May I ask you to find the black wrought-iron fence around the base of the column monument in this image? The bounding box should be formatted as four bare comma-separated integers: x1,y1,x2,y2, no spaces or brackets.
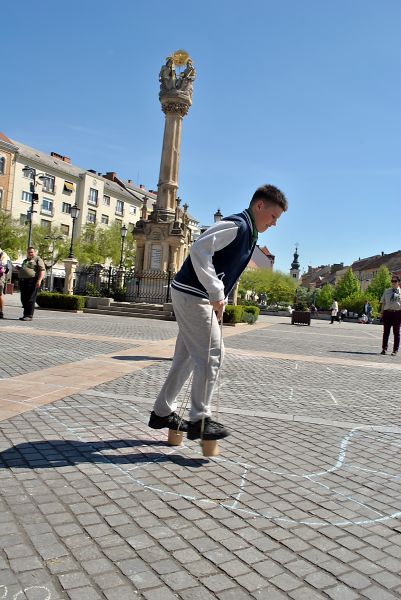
74,265,174,304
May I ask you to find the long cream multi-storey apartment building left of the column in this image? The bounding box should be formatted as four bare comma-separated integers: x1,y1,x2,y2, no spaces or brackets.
8,141,145,237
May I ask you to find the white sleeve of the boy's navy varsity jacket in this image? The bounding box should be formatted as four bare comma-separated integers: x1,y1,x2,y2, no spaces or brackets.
190,221,238,304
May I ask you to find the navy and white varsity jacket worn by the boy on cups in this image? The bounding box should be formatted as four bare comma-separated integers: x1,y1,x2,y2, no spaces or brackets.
171,210,257,302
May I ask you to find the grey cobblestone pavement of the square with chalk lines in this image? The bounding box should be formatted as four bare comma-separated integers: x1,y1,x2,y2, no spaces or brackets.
0,308,401,600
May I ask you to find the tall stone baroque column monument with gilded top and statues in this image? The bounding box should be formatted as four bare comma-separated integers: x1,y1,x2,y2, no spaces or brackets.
134,50,196,273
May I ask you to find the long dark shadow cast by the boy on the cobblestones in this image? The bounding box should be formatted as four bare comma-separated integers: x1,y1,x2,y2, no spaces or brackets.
0,440,209,469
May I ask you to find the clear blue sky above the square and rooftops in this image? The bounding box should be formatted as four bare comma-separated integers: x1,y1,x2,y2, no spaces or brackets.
0,0,401,271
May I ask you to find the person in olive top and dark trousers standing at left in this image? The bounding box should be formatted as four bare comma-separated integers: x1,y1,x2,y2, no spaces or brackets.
18,246,45,321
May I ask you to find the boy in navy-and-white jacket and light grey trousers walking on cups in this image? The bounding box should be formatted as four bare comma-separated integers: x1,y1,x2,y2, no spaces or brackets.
149,185,288,440
